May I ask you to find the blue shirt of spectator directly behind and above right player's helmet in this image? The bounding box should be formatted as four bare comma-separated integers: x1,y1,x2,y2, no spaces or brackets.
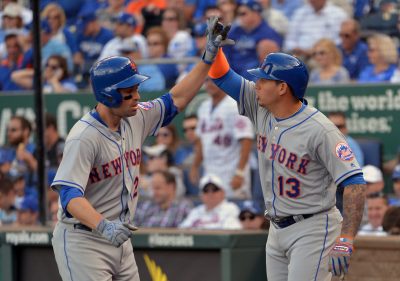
224,20,282,80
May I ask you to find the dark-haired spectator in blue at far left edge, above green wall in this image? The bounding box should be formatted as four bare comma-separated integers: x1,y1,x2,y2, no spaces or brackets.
0,33,26,91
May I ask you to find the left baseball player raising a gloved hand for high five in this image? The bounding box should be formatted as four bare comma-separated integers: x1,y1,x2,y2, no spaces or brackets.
52,18,232,281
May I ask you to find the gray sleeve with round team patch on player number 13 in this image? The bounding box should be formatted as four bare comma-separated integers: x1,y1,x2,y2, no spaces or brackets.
317,129,362,185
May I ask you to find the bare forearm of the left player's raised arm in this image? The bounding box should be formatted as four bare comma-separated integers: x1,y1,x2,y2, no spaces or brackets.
170,61,210,111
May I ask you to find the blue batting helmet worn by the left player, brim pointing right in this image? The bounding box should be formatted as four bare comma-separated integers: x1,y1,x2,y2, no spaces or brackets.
90,57,150,107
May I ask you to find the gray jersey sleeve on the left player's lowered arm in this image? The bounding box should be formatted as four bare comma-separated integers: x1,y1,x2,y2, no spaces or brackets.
51,139,96,193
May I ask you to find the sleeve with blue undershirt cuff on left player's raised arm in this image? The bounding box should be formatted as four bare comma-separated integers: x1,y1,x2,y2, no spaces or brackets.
138,93,178,138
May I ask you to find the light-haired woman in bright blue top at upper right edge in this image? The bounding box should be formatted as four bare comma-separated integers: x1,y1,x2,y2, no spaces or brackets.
358,34,398,83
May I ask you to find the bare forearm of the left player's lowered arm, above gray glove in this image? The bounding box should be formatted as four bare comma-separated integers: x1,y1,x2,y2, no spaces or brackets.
67,197,103,229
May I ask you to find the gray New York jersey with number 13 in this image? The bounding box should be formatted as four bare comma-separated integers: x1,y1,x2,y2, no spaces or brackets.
239,79,361,217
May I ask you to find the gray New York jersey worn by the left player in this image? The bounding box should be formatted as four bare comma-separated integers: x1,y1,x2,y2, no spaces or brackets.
52,99,165,224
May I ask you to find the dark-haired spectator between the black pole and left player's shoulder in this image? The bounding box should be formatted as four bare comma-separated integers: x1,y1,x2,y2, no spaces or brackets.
44,112,65,169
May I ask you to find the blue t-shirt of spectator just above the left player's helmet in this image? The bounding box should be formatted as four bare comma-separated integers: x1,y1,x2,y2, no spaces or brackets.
76,27,114,62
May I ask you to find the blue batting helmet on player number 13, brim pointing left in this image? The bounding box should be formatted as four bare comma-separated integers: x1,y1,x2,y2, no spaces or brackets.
247,53,308,99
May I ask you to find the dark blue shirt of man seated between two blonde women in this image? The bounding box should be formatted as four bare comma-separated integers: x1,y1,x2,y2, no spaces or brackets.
338,41,369,80
